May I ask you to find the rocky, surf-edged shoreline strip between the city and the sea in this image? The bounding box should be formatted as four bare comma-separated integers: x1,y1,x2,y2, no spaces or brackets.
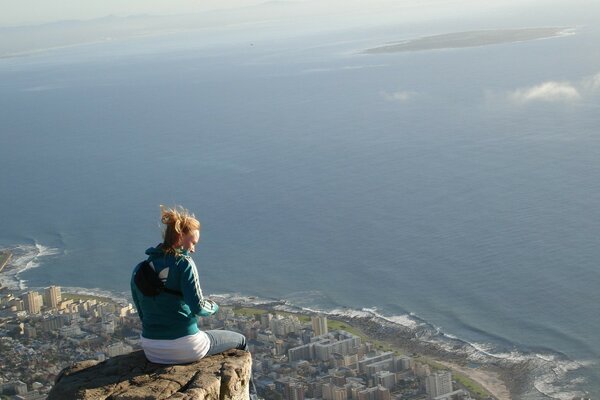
0,244,585,400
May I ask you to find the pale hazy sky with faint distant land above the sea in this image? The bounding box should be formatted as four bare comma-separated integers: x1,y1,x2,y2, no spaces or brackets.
0,0,600,57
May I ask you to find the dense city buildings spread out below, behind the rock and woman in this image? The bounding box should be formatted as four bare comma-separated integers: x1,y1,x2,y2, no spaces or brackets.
0,286,478,400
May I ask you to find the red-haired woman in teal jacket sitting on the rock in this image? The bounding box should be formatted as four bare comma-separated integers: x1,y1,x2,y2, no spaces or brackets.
131,206,253,366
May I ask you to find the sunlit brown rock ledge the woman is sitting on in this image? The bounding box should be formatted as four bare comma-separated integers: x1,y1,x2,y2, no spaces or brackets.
48,350,252,400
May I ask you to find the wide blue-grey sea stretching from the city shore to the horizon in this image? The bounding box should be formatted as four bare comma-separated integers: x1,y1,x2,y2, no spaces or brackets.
0,7,600,399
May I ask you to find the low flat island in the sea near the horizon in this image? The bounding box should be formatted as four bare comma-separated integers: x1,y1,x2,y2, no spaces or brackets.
362,27,572,54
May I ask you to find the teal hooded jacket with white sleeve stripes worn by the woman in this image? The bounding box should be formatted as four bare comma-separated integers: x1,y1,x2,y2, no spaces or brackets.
131,245,219,340
